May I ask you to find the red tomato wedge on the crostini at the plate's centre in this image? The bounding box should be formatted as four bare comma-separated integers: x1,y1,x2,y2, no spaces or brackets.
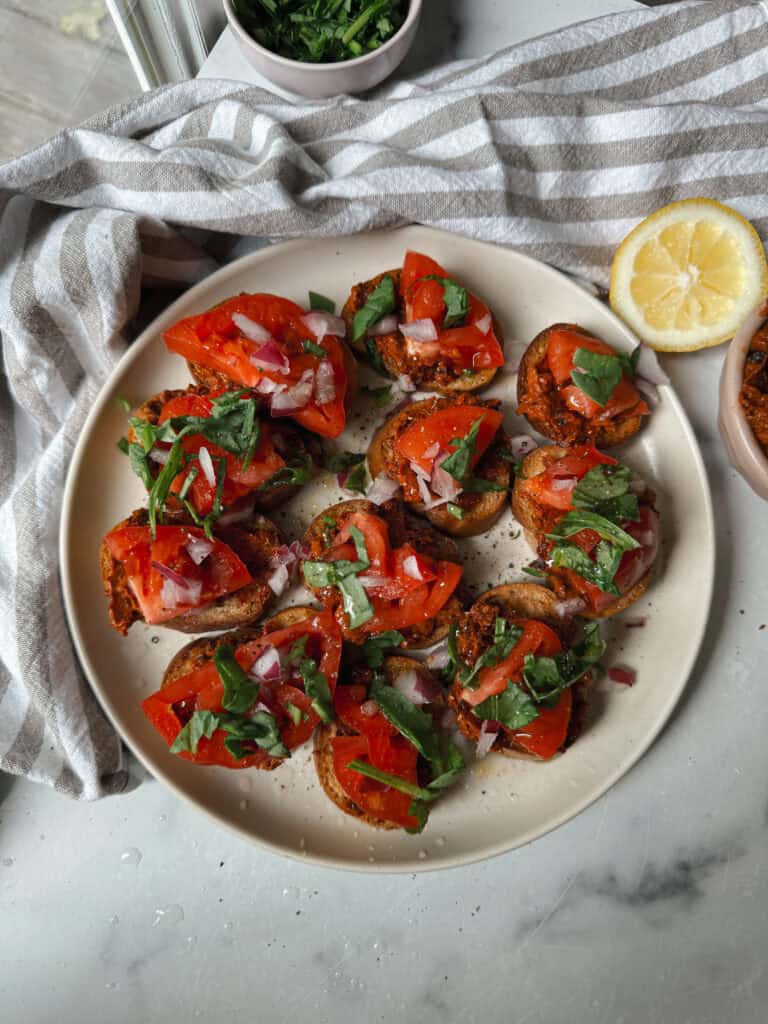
329,512,462,634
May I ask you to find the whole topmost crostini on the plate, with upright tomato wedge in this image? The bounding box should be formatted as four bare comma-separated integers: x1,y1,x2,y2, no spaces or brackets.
342,251,504,393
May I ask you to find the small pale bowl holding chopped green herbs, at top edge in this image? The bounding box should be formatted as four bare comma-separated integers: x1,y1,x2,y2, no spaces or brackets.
224,0,422,99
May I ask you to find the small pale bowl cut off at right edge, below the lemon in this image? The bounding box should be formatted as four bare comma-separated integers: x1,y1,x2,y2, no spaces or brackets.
718,300,768,500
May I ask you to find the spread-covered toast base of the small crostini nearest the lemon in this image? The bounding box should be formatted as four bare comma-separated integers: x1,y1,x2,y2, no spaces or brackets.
517,324,643,447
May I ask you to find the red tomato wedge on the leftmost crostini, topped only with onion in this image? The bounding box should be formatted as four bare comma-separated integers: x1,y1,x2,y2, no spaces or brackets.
104,526,253,626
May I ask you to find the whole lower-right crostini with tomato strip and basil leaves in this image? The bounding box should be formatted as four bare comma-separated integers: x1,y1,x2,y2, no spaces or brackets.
449,584,604,760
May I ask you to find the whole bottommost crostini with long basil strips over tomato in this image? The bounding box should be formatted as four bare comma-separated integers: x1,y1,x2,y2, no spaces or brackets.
314,656,464,831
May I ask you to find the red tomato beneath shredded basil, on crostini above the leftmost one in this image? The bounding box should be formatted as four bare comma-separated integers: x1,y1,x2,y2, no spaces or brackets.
156,394,286,515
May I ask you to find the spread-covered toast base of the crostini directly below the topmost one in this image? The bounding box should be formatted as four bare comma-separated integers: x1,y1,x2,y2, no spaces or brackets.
368,394,511,537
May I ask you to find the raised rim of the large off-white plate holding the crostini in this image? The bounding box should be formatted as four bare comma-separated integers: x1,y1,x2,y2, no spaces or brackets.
57,224,717,874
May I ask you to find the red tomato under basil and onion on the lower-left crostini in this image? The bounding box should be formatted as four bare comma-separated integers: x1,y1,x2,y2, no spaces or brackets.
141,611,341,768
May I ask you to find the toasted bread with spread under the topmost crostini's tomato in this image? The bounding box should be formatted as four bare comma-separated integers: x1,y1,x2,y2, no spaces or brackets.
341,269,502,394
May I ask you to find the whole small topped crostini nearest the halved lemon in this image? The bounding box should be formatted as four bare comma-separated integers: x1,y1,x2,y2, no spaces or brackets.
517,324,649,447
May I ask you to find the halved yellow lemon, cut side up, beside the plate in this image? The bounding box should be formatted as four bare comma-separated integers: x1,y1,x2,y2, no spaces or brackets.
610,199,768,352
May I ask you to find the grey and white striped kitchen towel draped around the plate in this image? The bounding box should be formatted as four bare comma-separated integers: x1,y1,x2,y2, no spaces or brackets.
0,0,768,799
